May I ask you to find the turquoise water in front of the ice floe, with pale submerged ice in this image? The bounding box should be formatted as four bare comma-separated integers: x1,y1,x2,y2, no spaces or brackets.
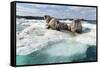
16,41,96,65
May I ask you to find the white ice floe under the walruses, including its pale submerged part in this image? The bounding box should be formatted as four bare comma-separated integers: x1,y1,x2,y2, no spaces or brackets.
16,20,96,57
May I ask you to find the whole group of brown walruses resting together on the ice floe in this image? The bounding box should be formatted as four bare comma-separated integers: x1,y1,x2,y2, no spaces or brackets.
44,15,82,33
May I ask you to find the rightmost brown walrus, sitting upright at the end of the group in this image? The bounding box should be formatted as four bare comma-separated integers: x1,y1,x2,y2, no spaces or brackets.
68,19,82,33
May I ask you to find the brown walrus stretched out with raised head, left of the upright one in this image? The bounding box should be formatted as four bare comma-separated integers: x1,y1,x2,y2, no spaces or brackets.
44,15,68,30
